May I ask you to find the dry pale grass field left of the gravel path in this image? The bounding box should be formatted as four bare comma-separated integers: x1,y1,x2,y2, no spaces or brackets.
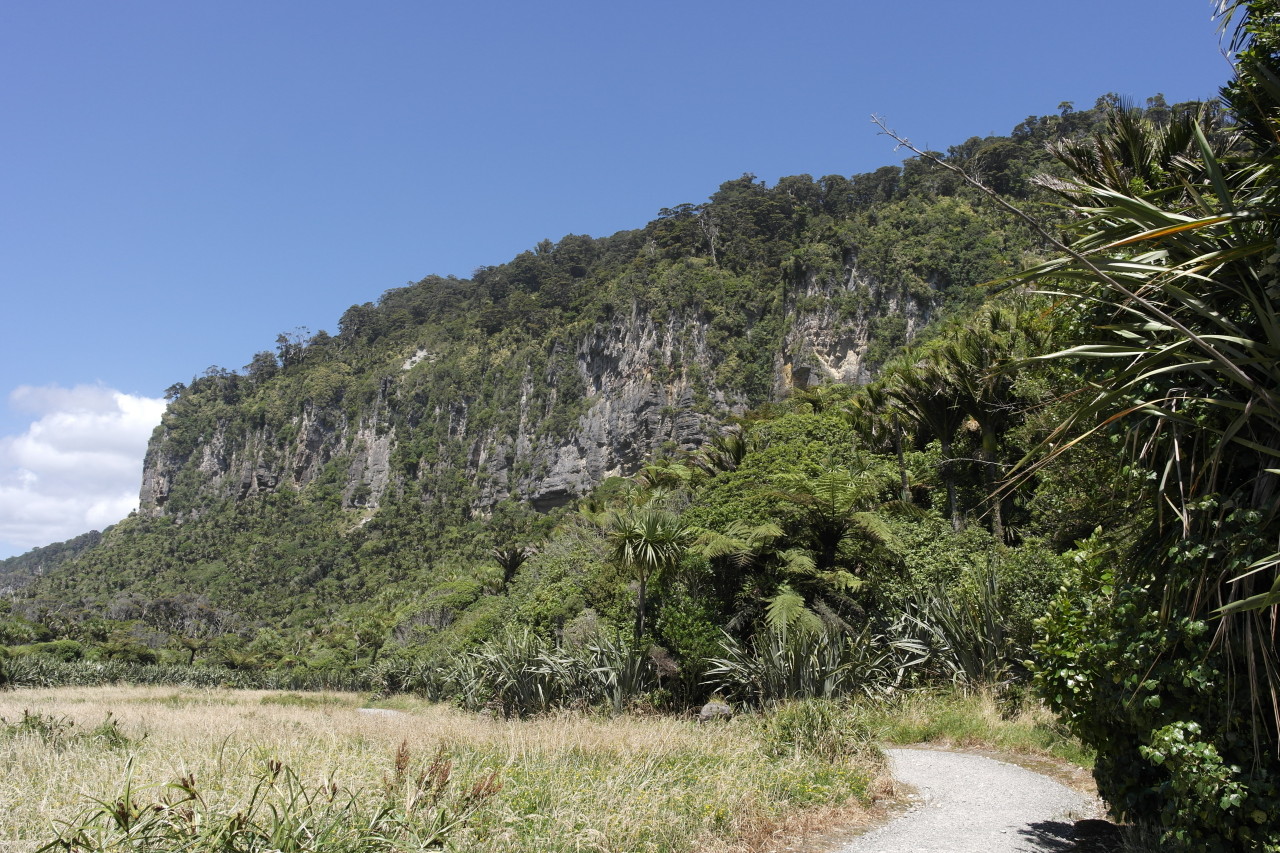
0,686,884,853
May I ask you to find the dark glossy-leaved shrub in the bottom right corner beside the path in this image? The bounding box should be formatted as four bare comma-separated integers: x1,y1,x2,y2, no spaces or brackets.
1036,540,1280,852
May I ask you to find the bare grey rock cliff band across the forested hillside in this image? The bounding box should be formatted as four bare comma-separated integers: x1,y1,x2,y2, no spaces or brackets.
140,269,929,516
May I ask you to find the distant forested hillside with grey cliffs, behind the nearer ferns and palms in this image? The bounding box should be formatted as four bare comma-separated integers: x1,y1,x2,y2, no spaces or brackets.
0,96,1152,637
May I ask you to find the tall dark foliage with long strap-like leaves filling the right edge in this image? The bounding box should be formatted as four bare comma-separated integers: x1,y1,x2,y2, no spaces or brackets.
1018,0,1280,850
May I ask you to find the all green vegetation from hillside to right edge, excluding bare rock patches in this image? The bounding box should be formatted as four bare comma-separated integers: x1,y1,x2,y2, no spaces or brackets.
0,0,1280,850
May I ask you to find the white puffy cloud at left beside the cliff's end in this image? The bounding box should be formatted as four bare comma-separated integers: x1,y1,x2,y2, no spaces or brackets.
0,386,165,556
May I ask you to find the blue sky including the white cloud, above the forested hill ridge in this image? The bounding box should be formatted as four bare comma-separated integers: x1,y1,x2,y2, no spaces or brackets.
0,0,1230,557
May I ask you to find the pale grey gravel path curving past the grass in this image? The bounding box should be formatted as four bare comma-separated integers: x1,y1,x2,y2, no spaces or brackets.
836,749,1097,853
